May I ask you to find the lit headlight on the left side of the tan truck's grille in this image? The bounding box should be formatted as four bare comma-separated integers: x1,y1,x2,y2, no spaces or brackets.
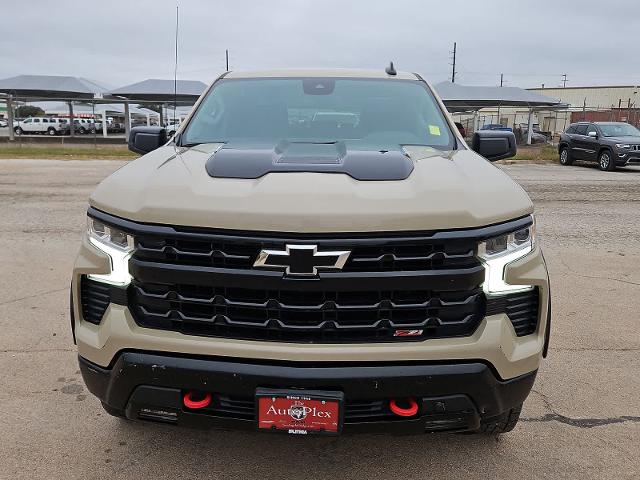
87,217,134,286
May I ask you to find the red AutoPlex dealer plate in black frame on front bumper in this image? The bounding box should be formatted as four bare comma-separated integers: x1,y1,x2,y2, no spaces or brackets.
256,388,344,435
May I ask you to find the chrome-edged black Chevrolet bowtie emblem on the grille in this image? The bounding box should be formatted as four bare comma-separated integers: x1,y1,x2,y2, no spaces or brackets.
253,245,351,276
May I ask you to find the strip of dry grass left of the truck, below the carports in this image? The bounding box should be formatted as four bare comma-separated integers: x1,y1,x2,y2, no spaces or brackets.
0,146,138,160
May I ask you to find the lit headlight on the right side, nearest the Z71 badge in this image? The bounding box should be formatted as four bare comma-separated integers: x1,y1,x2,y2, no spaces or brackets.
478,215,536,294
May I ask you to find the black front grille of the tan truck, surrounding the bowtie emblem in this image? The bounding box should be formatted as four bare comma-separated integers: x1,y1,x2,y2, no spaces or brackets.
89,209,531,343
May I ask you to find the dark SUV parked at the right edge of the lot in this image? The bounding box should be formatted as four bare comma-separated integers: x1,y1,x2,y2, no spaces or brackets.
558,122,640,170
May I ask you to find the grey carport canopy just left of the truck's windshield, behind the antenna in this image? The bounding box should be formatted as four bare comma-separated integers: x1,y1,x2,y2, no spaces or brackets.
108,78,207,105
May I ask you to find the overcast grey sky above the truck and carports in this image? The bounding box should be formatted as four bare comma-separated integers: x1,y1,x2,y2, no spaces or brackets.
0,0,640,87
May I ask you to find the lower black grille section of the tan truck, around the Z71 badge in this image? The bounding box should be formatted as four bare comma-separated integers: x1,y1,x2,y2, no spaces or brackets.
130,281,484,342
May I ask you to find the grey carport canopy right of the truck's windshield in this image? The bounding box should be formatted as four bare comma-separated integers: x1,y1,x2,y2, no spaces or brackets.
433,82,563,112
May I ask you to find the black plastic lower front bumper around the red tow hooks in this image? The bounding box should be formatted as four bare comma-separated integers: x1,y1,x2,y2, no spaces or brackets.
79,352,536,433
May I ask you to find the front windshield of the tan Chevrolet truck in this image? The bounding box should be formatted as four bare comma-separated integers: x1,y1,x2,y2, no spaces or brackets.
180,78,453,150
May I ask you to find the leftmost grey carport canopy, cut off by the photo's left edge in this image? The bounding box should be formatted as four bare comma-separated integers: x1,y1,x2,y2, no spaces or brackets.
0,75,107,99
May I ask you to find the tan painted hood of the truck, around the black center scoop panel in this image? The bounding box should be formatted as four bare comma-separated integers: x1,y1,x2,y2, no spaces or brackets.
90,144,533,233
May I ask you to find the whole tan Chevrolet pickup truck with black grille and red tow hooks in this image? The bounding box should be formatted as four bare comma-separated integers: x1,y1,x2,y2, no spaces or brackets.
71,69,550,434
